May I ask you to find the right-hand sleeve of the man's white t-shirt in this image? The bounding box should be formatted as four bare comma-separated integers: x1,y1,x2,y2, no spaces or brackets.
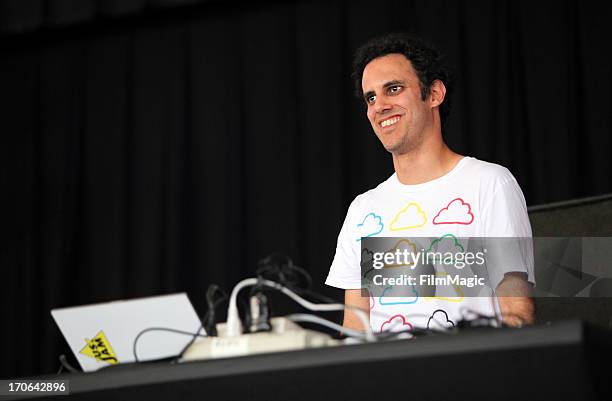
482,170,535,288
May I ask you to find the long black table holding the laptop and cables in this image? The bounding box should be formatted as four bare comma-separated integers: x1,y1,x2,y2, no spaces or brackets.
8,321,612,401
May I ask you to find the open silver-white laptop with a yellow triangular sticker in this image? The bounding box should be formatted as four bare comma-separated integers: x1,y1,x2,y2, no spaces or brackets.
51,293,203,372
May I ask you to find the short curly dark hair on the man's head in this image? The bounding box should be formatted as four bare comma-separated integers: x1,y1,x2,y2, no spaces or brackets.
352,33,453,126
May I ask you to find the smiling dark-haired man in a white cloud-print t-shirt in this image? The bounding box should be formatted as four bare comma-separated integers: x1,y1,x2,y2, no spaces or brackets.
326,34,534,332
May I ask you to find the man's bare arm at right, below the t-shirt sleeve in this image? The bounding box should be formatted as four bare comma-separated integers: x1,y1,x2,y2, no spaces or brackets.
496,272,535,326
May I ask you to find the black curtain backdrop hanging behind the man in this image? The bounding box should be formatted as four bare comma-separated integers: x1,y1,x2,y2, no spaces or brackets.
0,0,612,377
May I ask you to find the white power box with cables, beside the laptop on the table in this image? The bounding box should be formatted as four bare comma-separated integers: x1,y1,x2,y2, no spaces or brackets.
182,317,341,361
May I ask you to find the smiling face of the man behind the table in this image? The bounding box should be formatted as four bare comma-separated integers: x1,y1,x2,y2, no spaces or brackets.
361,54,432,154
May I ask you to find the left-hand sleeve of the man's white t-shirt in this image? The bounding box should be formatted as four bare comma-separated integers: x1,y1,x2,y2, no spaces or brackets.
325,198,361,290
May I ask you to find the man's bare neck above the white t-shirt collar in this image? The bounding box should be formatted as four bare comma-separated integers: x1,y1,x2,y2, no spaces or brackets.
393,138,463,185
